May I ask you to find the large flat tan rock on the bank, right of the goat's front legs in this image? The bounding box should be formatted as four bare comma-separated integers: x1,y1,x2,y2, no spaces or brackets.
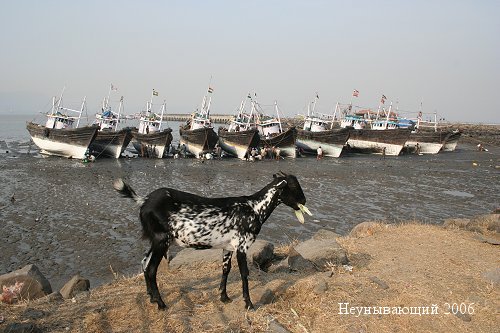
289,231,349,270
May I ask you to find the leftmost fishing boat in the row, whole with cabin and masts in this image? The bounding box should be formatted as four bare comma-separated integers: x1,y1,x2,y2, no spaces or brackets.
26,89,98,160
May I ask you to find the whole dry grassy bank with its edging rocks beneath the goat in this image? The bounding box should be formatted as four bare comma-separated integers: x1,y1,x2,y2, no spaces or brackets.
0,212,500,332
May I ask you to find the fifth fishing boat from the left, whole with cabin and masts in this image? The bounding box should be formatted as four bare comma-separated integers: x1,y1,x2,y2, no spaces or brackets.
218,99,260,160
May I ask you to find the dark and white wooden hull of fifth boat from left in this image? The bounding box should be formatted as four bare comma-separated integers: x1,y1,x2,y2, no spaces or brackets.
219,128,260,160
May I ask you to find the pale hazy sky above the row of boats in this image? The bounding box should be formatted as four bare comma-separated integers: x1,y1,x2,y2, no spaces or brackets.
0,0,500,123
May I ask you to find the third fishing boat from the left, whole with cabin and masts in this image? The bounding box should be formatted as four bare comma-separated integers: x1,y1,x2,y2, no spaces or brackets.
132,90,172,158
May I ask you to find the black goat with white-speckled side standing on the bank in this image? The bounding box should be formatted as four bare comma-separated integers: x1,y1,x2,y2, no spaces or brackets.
113,172,311,309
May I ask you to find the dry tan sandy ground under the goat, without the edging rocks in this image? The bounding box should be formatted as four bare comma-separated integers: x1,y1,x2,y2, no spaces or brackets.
0,223,500,332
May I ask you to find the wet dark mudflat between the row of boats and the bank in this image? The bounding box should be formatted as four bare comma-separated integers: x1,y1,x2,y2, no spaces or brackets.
0,142,500,289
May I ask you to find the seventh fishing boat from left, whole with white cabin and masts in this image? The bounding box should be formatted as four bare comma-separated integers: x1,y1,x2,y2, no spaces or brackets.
296,94,349,157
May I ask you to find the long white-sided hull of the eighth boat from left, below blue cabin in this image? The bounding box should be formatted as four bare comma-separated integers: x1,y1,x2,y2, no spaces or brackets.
347,128,411,156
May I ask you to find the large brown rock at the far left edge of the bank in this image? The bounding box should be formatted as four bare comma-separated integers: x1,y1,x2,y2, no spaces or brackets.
0,265,52,300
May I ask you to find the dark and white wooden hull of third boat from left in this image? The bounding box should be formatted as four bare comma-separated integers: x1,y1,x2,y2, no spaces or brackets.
132,128,172,158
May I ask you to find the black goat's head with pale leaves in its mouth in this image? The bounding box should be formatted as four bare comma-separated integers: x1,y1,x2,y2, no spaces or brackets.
273,171,312,223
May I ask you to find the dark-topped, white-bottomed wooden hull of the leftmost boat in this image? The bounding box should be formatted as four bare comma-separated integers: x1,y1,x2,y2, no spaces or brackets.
26,122,98,160
